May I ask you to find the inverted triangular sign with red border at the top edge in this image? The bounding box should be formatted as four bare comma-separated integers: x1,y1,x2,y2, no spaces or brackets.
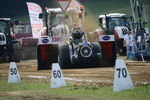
57,0,72,13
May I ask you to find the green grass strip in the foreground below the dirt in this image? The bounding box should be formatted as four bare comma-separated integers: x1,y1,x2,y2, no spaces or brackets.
0,81,150,100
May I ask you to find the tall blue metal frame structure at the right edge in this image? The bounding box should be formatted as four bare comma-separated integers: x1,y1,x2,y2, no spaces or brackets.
127,0,150,61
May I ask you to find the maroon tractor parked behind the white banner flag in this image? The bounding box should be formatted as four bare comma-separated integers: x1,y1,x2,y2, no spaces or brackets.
12,22,38,60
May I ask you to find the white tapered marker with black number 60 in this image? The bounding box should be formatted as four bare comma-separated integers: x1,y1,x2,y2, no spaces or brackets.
51,63,66,88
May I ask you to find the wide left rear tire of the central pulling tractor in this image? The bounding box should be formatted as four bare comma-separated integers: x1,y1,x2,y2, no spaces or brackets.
58,44,71,69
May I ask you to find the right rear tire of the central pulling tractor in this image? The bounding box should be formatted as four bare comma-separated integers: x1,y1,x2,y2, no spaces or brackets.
92,42,102,67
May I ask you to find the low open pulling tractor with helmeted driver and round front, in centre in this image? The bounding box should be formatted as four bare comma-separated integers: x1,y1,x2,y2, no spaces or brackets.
58,26,102,68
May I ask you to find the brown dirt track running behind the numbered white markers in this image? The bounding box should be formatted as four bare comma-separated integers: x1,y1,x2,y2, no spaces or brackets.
0,57,150,86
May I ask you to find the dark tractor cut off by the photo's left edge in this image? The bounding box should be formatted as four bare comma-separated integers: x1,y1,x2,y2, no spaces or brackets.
0,18,21,63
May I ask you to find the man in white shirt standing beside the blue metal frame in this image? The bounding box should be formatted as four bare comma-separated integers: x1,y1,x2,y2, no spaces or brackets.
123,30,134,57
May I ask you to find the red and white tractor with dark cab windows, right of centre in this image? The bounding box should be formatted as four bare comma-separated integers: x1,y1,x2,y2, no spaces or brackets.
99,13,128,55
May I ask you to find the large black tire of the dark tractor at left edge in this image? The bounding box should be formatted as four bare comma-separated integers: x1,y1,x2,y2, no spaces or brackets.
10,42,21,62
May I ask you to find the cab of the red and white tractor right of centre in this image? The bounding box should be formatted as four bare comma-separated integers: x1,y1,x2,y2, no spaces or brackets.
99,13,127,34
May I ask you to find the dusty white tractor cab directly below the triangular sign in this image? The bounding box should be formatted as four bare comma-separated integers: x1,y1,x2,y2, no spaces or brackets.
39,8,78,37
